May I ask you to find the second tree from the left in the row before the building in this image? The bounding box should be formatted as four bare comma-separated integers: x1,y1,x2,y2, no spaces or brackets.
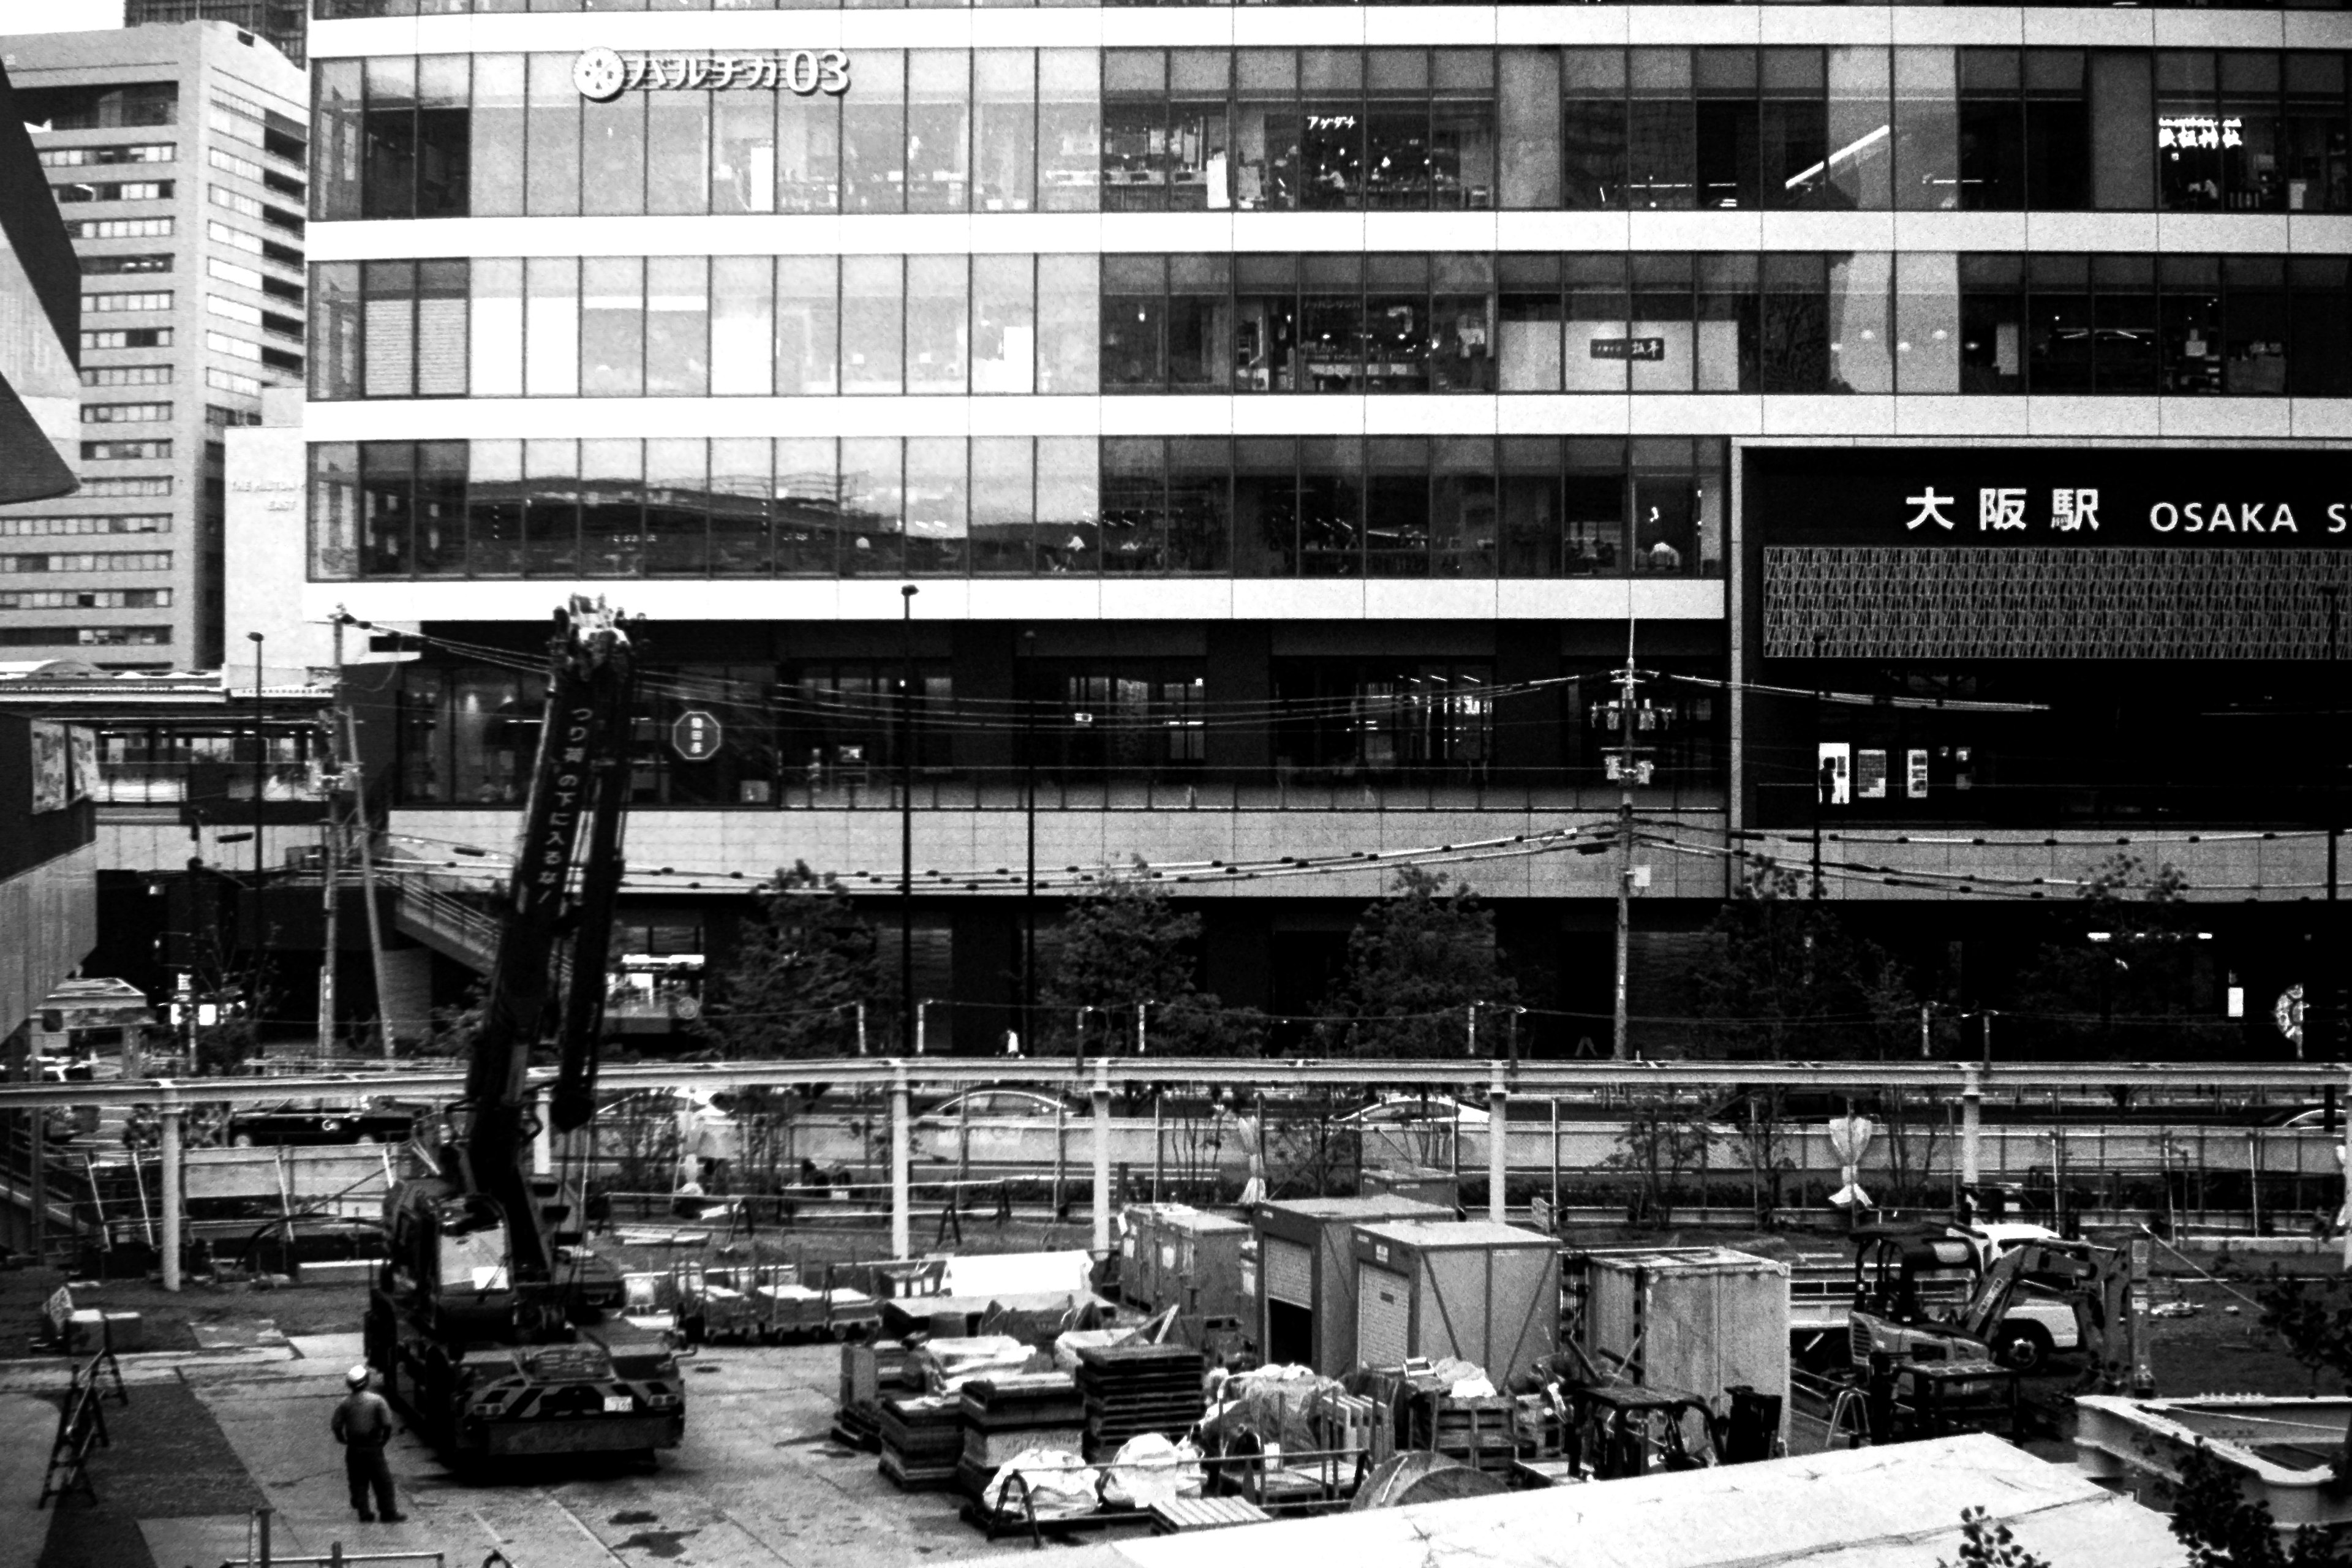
1039,861,1263,1055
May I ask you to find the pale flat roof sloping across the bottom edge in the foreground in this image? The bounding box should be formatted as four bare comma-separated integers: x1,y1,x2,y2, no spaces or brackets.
1061,1431,2187,1568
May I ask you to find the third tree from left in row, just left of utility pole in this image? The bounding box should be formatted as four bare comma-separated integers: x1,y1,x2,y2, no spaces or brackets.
1315,865,1520,1058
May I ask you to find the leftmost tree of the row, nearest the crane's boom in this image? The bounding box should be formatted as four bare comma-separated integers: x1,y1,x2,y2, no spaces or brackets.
696,861,882,1058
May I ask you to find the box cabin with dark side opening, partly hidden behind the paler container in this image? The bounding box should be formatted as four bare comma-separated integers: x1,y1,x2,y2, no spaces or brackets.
1251,1197,1453,1378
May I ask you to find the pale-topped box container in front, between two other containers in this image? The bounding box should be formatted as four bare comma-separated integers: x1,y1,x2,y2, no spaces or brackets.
1352,1220,1559,1387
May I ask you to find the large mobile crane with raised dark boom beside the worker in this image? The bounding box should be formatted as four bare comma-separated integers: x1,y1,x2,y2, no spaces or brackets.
364,595,687,1462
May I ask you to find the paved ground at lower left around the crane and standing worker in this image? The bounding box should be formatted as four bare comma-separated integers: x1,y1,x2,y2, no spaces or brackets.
0,1335,1009,1568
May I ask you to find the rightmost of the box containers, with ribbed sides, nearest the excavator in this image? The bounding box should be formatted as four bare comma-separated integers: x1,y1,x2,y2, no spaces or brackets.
1564,1246,1787,1434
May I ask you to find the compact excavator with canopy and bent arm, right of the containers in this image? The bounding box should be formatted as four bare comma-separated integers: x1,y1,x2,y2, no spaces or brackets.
1849,1234,2157,1438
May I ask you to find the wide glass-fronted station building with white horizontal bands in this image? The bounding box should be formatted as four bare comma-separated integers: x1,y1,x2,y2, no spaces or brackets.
301,0,2352,1049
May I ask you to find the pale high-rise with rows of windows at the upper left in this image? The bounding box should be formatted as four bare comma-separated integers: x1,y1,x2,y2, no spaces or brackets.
0,21,308,668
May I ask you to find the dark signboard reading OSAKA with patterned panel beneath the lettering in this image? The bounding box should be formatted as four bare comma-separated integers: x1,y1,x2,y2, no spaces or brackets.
1741,447,2352,661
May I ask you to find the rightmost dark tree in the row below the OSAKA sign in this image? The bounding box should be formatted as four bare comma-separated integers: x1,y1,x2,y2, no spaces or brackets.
2013,853,2237,1060
